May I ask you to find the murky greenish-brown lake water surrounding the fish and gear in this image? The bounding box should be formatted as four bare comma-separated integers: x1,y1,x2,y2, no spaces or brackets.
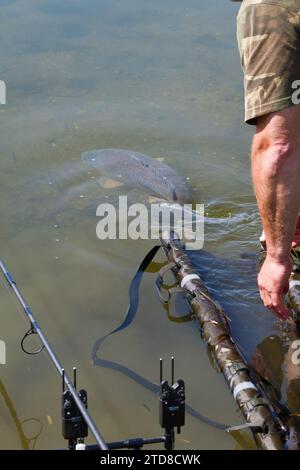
0,0,296,449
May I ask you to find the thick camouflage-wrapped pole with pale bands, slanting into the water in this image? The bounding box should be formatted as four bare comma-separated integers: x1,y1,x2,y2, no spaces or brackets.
161,232,284,450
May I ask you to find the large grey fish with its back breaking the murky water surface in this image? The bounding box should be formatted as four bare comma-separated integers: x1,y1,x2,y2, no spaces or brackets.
81,149,191,204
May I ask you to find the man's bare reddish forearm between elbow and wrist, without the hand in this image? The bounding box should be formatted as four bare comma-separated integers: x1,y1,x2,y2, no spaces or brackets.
252,136,300,261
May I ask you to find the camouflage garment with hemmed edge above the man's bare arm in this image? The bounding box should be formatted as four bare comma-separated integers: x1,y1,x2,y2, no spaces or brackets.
237,0,300,124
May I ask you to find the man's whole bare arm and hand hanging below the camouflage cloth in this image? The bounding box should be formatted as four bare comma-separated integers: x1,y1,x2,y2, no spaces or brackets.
252,106,300,319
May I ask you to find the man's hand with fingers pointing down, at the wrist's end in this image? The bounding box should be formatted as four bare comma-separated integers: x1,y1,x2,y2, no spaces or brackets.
257,254,292,320
